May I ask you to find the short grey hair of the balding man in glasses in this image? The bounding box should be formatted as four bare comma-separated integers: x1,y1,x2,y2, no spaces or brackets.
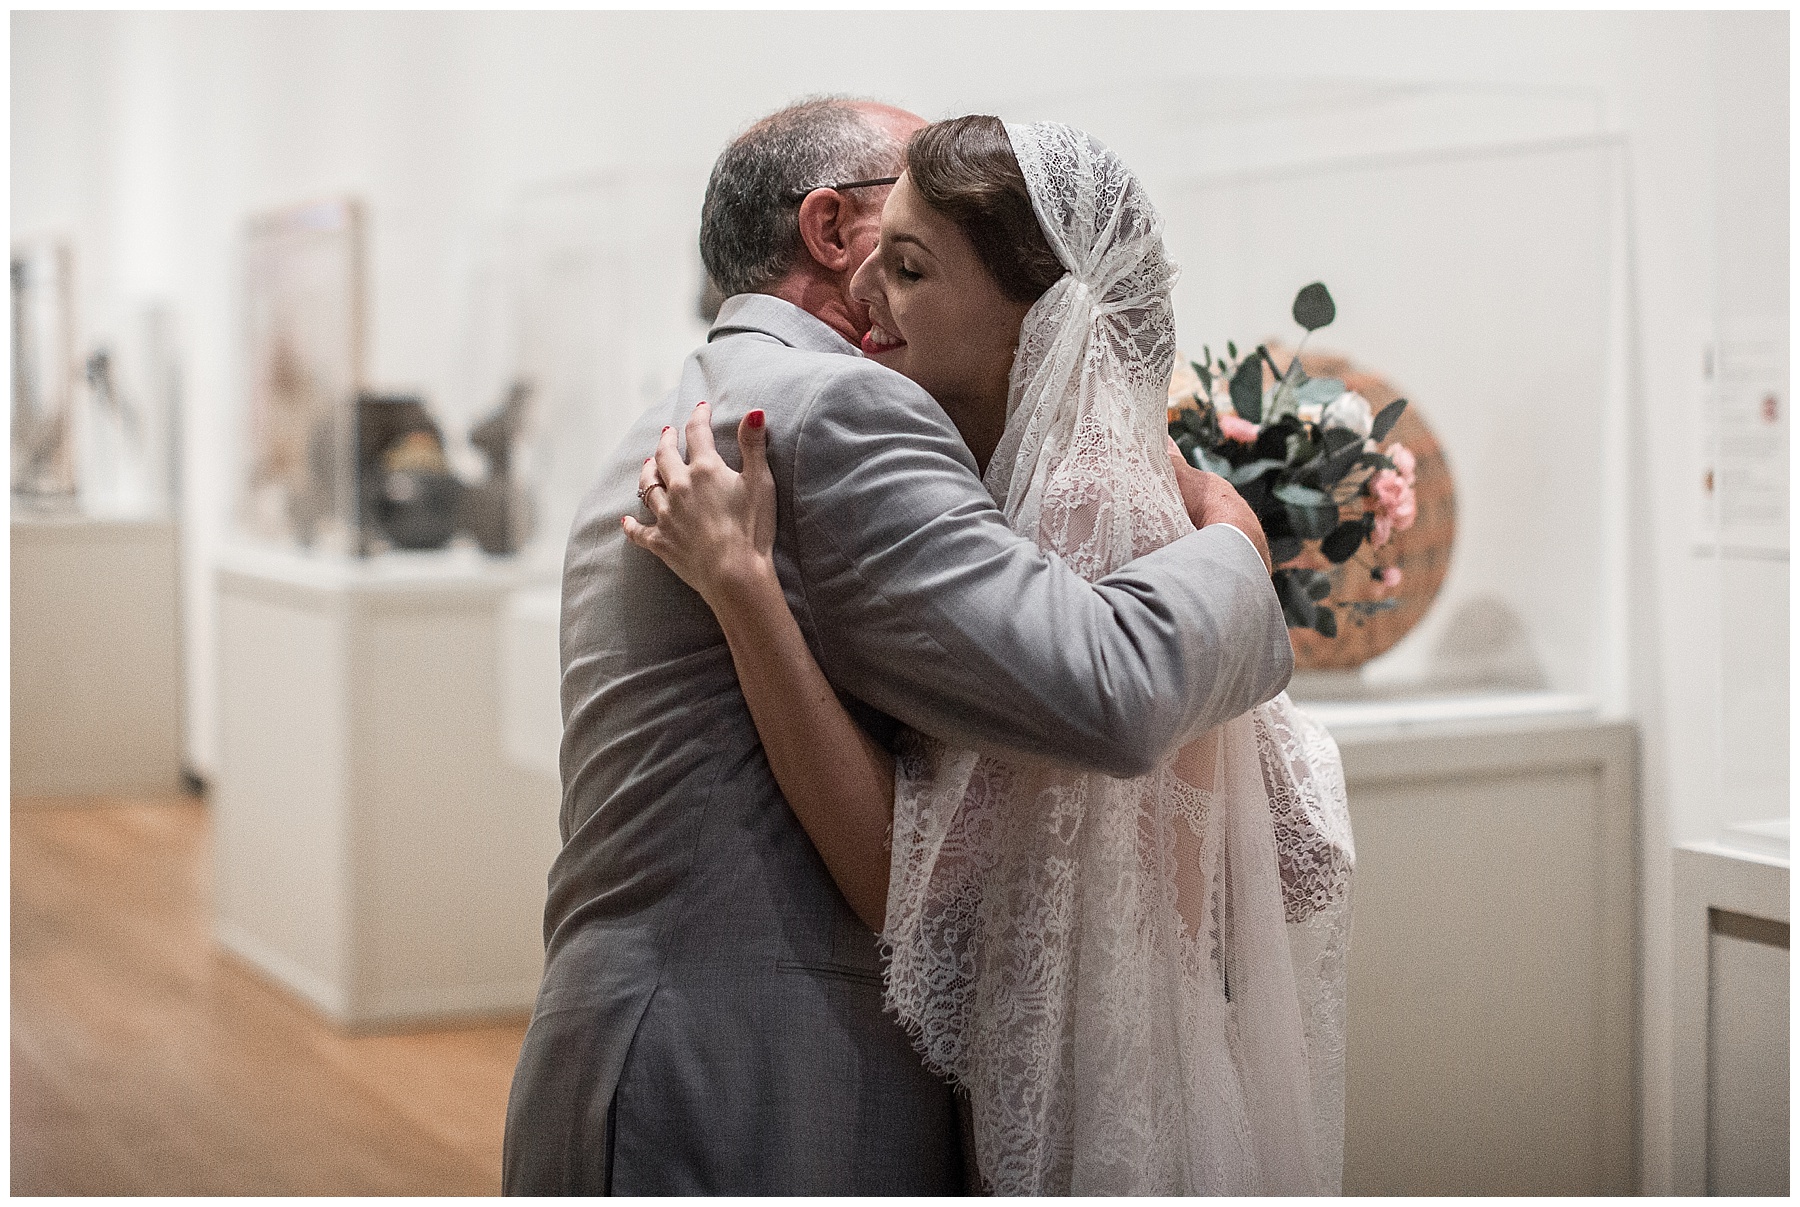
700,97,905,297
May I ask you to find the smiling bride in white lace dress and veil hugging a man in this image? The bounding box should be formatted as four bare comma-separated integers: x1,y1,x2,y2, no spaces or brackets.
623,117,1352,1194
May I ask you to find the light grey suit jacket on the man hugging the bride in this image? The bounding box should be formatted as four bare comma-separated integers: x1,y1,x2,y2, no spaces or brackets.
504,295,1291,1194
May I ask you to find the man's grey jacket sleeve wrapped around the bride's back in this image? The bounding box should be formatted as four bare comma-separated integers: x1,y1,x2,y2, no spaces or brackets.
779,358,1292,775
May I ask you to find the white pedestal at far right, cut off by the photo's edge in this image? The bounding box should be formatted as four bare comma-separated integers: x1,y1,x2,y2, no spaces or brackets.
1670,841,1789,1198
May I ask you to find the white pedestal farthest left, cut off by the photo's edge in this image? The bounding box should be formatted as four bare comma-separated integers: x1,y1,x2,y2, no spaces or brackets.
13,516,182,797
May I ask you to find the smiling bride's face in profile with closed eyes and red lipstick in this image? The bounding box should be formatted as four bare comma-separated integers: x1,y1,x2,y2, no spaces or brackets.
850,176,1031,453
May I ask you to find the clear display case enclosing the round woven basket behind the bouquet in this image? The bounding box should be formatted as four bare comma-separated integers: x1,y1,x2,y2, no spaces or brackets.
1012,81,1629,705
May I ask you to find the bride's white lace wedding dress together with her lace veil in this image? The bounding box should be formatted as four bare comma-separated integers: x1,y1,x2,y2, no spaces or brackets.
884,124,1352,1194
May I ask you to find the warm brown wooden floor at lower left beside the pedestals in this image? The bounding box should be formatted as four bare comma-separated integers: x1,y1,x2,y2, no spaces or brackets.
13,799,526,1194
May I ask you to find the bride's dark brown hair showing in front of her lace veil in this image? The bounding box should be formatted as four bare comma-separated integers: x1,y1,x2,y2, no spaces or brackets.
905,113,1064,302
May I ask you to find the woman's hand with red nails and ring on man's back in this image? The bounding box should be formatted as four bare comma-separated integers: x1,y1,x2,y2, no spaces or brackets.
619,403,776,610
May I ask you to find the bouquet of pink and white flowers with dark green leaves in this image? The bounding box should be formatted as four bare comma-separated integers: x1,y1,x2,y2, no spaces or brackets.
1168,282,1418,637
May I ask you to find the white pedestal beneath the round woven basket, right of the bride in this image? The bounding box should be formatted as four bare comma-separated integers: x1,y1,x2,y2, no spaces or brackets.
1301,693,1636,1194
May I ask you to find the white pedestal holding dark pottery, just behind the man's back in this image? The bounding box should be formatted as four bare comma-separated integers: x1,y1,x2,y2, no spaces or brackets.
214,550,560,1025
